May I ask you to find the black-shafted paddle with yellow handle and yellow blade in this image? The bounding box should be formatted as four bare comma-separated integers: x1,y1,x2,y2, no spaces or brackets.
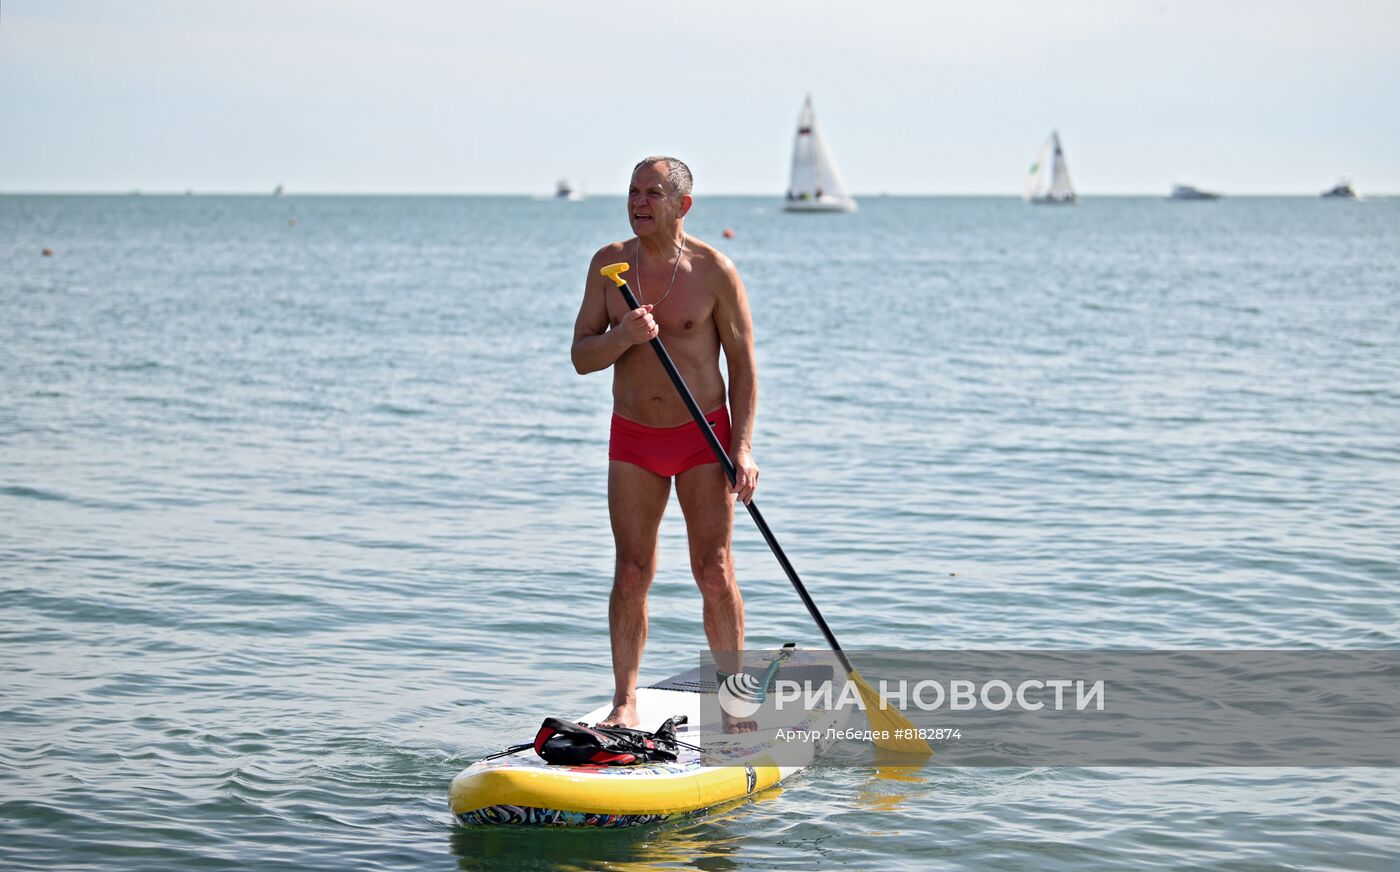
598,263,934,754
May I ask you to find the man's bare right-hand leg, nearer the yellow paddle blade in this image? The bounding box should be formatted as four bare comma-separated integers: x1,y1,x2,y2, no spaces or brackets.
676,463,756,731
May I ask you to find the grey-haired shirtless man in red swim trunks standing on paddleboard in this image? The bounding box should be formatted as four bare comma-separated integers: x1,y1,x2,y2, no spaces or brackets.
571,157,759,729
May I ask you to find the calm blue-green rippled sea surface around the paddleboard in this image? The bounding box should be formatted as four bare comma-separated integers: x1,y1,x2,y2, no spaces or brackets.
0,196,1400,871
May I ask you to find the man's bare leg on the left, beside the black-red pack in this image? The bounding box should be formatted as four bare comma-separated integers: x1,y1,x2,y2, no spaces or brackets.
601,460,671,726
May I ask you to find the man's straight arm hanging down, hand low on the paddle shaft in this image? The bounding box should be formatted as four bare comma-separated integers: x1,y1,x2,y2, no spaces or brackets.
714,255,759,502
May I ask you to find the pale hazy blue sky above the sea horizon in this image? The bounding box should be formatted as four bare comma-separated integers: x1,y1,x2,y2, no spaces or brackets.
0,0,1400,196
